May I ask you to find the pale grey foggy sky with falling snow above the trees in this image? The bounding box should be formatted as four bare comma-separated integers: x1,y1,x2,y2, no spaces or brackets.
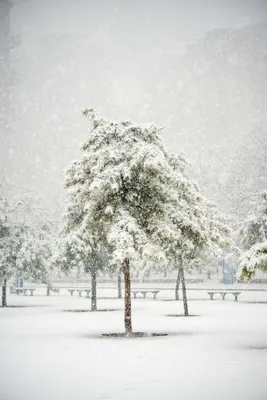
0,0,267,218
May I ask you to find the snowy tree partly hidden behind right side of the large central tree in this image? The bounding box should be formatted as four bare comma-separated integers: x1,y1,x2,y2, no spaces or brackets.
159,155,228,315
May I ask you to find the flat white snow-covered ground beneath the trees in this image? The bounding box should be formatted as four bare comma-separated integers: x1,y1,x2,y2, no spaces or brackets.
0,291,267,400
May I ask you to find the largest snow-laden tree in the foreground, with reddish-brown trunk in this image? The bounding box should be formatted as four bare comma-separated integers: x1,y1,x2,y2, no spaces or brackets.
66,110,186,333
